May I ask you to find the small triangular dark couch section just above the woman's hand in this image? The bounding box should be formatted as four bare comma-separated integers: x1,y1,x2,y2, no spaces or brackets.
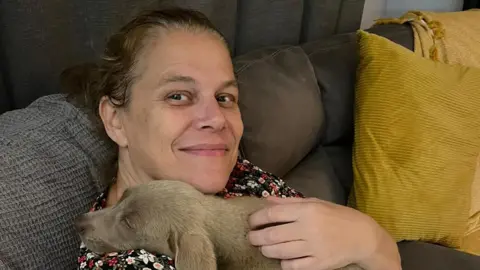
284,146,345,205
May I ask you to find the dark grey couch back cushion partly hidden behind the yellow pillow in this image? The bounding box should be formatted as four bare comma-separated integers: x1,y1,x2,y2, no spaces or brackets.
302,25,413,146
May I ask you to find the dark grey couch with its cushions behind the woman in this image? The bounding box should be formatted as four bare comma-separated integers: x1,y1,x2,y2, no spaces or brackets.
0,0,480,270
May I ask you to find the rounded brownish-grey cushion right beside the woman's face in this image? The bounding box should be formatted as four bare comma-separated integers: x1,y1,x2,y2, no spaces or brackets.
234,46,323,176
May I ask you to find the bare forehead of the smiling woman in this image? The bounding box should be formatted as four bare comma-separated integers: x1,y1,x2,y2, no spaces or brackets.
137,32,235,85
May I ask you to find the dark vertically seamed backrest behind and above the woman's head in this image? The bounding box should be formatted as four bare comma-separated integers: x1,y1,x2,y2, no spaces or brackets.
0,0,364,113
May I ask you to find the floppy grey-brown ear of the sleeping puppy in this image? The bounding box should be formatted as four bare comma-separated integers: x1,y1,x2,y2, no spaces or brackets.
175,233,217,270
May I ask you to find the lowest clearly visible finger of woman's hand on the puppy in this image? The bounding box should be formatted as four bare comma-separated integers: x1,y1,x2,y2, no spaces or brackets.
260,240,312,260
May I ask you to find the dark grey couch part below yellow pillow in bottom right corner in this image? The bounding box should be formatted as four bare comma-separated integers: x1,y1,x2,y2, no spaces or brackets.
398,241,480,270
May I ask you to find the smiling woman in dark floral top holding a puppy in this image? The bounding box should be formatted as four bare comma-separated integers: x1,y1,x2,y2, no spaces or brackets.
64,9,401,270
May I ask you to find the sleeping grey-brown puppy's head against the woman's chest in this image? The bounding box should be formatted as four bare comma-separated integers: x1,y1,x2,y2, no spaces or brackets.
75,180,205,256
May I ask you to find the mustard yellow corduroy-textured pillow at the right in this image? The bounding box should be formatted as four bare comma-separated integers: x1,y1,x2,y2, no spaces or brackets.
349,31,480,251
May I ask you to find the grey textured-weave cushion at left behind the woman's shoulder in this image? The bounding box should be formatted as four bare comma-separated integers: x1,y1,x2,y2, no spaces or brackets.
0,95,112,270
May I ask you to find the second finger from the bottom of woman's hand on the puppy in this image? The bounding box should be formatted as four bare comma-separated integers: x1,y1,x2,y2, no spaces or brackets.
248,223,303,246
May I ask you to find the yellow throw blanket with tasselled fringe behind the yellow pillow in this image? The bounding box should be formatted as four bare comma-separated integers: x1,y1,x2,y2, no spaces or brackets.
376,9,480,255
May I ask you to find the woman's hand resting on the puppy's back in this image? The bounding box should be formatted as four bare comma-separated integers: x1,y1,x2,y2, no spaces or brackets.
248,197,401,270
